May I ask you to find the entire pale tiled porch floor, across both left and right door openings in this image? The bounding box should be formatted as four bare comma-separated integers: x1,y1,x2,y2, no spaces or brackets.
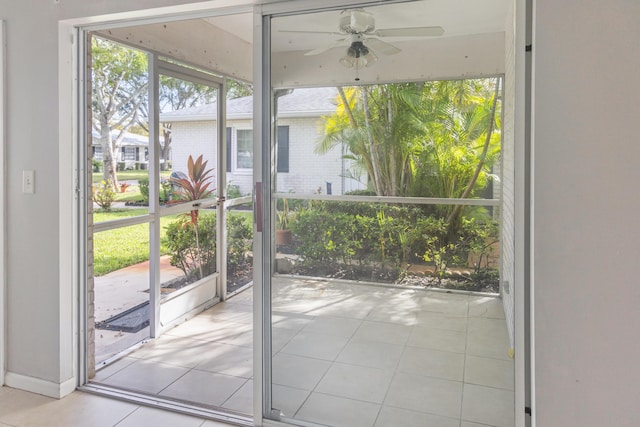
70,278,514,427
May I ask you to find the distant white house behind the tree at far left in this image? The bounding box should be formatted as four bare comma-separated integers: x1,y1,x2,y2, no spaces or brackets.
91,130,171,169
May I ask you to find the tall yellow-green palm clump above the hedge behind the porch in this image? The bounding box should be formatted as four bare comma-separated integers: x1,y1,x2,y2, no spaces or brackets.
316,78,500,237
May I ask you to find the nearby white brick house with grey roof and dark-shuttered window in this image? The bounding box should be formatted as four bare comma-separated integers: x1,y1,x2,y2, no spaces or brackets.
160,87,366,194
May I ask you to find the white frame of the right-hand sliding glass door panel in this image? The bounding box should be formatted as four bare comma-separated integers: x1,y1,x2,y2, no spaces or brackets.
253,0,535,427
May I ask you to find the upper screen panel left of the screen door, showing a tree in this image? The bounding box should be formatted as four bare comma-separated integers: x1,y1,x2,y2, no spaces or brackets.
88,37,149,222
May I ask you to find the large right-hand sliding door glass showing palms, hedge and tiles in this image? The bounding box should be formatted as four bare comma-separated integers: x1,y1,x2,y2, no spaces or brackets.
263,1,514,426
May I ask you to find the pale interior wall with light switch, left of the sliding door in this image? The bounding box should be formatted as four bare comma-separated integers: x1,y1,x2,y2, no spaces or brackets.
0,0,234,396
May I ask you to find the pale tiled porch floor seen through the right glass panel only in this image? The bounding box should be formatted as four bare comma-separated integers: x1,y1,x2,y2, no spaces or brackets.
273,279,514,427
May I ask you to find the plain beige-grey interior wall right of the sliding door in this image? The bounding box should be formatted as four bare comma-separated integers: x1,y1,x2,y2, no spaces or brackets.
533,0,640,427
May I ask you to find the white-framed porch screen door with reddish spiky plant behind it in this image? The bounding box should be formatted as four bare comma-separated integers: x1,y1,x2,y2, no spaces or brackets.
158,69,224,327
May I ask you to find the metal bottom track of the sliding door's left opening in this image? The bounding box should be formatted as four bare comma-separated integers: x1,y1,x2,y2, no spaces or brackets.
78,383,254,426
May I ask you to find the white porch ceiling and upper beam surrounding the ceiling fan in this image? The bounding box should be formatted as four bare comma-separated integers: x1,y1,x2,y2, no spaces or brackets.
96,0,509,87
